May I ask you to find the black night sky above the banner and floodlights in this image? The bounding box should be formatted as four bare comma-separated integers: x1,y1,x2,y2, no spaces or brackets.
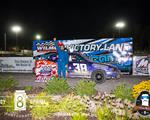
0,0,150,50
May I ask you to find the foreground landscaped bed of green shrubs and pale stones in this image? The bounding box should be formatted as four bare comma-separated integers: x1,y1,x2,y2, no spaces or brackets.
0,77,149,120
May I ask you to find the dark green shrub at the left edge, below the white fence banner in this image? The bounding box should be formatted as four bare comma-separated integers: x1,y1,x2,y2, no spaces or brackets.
0,76,18,91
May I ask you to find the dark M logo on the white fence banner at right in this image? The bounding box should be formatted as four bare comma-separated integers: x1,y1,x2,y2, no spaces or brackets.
136,57,149,74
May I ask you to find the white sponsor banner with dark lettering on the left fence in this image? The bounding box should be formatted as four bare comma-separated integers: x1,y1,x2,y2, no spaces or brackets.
0,57,34,73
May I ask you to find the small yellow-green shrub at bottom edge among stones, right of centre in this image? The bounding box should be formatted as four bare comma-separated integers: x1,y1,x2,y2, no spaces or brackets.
96,105,115,120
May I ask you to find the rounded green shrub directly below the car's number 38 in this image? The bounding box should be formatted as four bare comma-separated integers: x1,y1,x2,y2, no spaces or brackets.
74,80,96,96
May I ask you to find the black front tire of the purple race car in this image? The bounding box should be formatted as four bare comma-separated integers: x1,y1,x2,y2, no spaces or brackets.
91,70,106,83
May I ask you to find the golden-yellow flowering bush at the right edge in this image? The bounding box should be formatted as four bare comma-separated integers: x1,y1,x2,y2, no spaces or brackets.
132,80,150,98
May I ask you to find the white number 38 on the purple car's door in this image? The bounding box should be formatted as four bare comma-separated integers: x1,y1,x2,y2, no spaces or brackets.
73,63,88,72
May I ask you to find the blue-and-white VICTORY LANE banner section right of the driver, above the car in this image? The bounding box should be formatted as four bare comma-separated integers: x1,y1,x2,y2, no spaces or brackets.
63,38,133,74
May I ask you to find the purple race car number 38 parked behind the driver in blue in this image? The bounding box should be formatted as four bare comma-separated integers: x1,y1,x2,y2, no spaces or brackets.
34,53,120,83
